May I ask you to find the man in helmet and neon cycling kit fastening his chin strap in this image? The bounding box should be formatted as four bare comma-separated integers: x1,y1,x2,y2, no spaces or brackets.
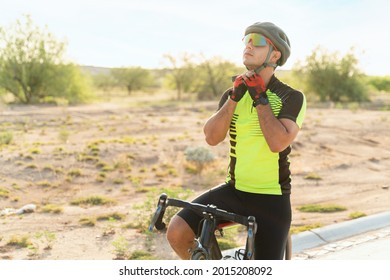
167,22,306,259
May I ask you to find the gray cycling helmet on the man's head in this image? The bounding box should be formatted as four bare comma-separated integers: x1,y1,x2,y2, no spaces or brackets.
245,22,291,66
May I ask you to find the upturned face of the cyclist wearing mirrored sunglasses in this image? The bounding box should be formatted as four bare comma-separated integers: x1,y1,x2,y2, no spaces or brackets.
242,33,280,70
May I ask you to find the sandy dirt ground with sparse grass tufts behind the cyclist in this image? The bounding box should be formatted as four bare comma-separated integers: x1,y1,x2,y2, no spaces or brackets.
0,96,390,260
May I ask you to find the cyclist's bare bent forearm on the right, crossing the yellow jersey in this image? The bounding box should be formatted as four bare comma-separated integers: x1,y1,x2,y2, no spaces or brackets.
256,105,299,153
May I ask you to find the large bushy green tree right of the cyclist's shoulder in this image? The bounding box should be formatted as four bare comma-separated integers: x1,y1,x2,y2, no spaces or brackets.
294,47,368,102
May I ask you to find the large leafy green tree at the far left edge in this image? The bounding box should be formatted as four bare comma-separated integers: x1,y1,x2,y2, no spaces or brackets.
0,16,88,104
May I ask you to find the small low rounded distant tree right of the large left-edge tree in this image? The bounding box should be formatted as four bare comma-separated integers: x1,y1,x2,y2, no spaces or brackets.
111,67,153,94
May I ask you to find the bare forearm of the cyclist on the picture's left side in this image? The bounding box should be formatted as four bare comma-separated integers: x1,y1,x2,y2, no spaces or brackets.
203,99,237,146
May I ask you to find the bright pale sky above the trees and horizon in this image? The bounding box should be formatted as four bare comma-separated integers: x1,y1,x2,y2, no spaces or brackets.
0,0,390,75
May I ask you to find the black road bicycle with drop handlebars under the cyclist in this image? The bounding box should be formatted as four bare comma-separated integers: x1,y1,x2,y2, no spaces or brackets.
149,193,291,260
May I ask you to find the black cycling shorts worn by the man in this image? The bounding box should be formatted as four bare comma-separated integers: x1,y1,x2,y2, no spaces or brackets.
177,183,291,260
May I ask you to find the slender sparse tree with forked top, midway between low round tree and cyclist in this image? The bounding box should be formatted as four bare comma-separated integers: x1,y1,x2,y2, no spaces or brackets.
164,53,195,100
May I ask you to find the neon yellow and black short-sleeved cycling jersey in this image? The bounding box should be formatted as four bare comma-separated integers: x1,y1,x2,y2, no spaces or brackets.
220,76,306,195
